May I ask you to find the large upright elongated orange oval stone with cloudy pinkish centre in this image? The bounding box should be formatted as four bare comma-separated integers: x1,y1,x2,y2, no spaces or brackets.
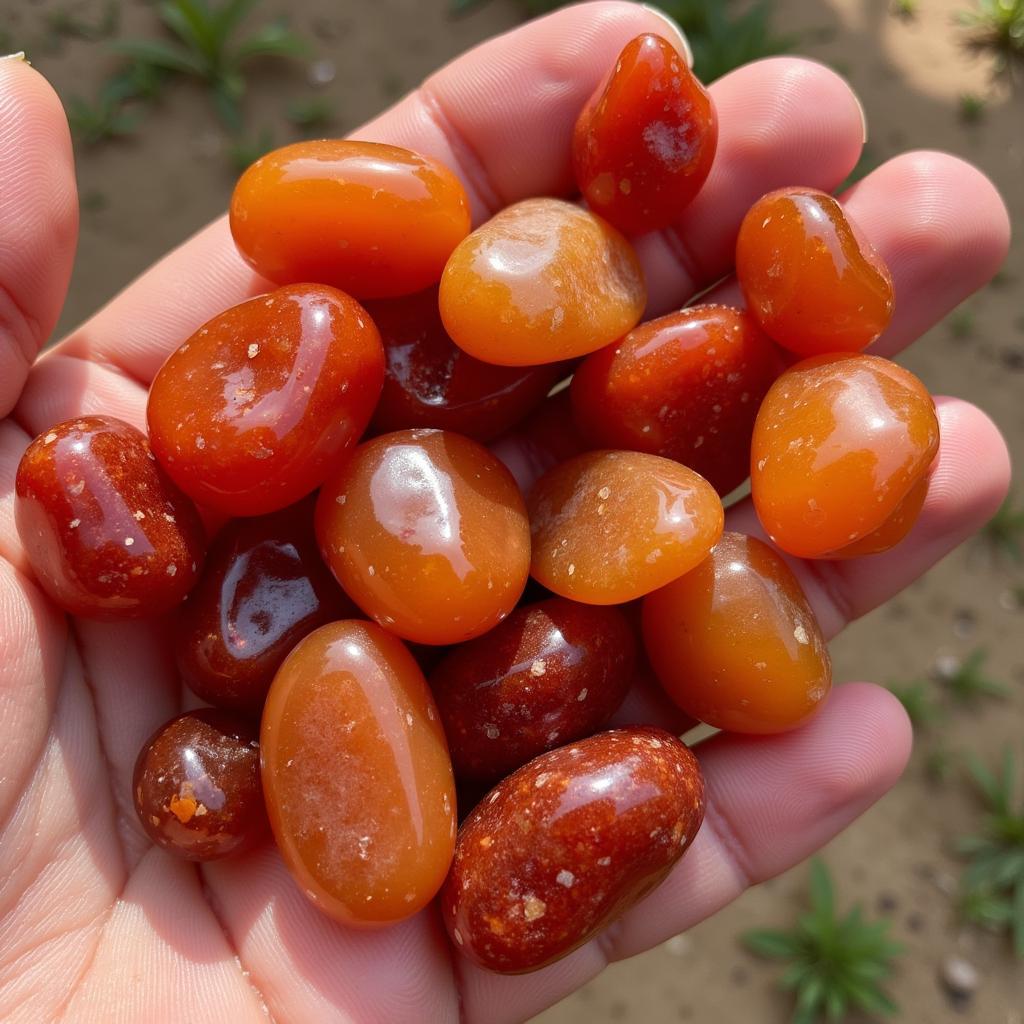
260,620,456,926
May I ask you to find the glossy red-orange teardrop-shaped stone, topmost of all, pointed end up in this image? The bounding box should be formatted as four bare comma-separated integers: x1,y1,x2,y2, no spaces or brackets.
572,34,718,234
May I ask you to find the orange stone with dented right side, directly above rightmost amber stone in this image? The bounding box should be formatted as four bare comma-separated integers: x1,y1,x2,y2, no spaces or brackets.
736,188,894,355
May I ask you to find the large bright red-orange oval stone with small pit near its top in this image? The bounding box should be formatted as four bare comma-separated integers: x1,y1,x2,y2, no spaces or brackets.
147,285,384,516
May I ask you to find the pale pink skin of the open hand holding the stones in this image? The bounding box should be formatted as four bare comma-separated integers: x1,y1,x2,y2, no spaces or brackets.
0,2,1009,1024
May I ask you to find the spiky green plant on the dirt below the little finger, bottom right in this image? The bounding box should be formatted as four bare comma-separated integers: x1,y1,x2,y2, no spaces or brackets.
742,858,903,1024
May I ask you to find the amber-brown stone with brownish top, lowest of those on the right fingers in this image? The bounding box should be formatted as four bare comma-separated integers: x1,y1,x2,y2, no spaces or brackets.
643,534,831,733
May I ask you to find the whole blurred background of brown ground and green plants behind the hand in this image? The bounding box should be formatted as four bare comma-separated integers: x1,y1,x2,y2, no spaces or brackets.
0,0,1024,1024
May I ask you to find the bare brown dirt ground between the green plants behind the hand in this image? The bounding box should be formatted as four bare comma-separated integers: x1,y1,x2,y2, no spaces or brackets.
0,0,1024,1024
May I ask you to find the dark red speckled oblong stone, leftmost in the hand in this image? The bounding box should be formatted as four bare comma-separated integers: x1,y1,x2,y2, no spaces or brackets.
14,416,206,618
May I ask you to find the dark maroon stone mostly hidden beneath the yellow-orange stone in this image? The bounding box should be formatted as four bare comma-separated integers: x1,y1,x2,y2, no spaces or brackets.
367,288,560,441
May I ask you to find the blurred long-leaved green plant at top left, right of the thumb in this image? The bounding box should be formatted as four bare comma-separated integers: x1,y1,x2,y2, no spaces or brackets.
112,0,306,133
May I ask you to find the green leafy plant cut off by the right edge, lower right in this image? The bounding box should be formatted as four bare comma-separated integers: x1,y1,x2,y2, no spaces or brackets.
956,746,1024,956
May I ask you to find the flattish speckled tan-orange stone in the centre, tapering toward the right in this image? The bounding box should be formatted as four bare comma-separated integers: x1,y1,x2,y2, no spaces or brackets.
529,452,724,604
